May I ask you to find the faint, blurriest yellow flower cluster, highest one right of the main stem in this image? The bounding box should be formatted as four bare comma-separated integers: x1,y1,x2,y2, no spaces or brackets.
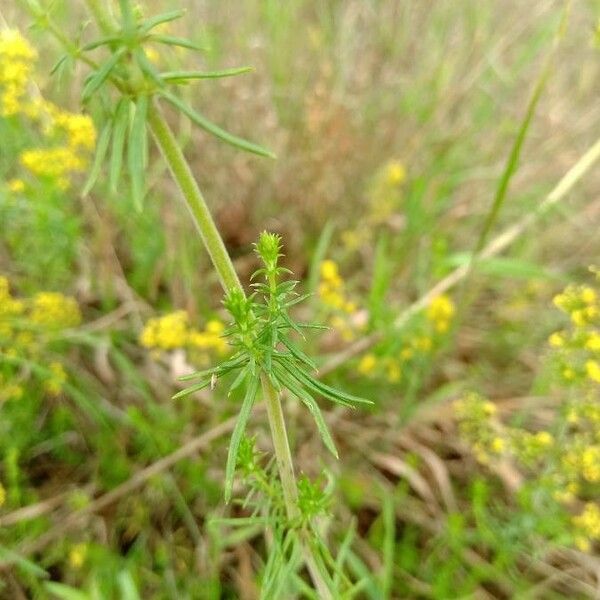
342,159,406,250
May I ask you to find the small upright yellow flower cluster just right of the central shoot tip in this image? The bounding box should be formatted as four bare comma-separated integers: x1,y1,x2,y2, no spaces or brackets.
318,259,360,342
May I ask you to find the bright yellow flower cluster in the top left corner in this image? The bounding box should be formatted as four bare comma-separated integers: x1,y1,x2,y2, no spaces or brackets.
0,30,96,186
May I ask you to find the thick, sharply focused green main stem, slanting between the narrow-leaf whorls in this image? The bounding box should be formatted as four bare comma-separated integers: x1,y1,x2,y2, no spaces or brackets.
148,103,333,600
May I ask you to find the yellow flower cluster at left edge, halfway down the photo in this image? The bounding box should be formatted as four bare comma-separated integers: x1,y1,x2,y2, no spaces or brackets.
0,276,81,402
